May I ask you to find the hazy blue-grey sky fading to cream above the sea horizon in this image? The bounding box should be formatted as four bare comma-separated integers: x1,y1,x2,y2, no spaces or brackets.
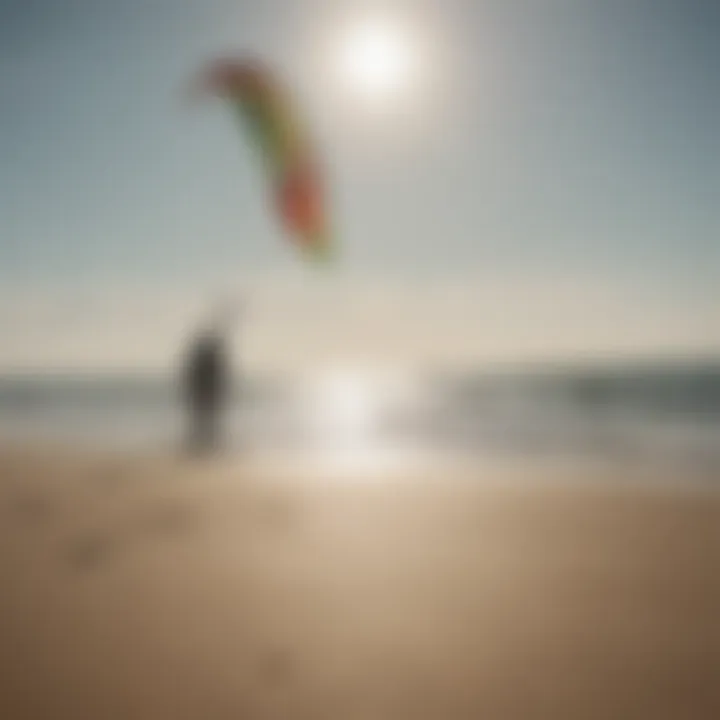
0,0,720,368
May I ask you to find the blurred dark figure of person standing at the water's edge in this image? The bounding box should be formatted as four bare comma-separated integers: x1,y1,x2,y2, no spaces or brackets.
184,333,228,450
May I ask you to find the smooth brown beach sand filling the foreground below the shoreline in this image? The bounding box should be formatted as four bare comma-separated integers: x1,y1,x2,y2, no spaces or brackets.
0,448,720,720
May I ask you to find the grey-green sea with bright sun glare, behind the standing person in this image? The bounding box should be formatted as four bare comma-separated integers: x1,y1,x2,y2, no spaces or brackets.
0,361,720,479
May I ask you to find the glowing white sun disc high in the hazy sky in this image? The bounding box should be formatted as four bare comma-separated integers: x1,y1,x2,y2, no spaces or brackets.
337,19,416,104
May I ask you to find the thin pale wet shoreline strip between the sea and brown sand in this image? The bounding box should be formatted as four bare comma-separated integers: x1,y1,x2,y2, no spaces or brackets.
0,439,720,495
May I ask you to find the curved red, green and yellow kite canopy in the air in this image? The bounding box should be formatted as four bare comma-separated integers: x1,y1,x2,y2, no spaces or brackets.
195,59,331,259
